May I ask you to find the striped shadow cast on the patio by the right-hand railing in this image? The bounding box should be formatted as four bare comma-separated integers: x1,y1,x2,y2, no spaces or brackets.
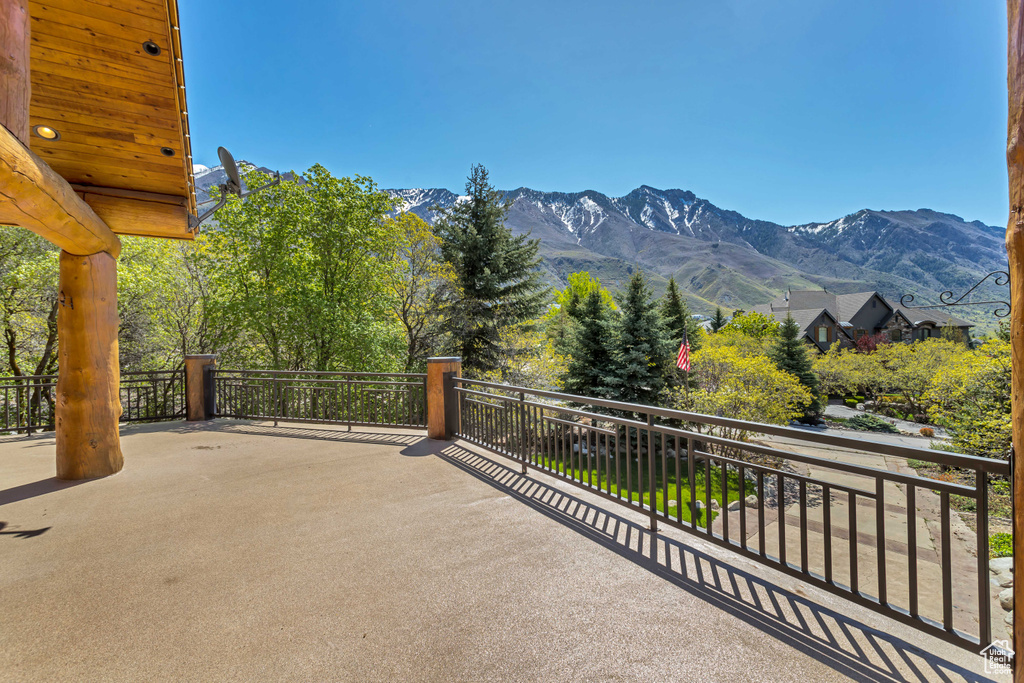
433,441,992,681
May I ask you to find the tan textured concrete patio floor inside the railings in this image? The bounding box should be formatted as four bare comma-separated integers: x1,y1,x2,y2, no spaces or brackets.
0,420,1007,682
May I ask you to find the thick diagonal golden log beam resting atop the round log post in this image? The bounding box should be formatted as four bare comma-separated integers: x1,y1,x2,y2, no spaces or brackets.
0,126,121,258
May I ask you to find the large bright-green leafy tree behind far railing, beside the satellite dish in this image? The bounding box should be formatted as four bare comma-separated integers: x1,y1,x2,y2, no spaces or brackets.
206,165,406,372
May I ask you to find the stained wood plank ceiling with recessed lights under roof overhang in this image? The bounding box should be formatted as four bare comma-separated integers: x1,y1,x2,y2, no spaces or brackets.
29,0,196,240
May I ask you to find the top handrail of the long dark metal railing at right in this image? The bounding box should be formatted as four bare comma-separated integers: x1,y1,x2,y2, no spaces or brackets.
452,377,1010,475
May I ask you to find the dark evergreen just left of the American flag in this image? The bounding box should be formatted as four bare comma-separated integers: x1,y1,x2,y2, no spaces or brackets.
610,272,672,403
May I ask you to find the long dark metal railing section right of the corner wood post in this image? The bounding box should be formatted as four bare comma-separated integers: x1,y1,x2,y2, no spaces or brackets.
452,378,1010,651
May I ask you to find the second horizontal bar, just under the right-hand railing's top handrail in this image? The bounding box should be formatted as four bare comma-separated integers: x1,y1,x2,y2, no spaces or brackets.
456,388,979,498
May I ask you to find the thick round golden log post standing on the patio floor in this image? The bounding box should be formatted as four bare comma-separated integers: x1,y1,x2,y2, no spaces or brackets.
56,252,124,479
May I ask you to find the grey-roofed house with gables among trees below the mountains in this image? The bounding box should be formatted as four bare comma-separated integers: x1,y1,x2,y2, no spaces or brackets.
752,290,974,352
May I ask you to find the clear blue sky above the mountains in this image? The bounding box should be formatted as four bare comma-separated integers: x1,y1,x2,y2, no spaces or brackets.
179,0,1008,225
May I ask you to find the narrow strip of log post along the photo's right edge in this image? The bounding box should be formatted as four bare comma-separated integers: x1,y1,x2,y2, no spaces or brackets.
1007,0,1024,671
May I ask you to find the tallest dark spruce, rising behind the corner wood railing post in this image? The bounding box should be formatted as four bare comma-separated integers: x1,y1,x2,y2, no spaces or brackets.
434,165,549,375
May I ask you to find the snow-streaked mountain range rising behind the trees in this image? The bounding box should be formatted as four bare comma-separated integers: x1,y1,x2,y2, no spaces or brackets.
188,167,1007,312
